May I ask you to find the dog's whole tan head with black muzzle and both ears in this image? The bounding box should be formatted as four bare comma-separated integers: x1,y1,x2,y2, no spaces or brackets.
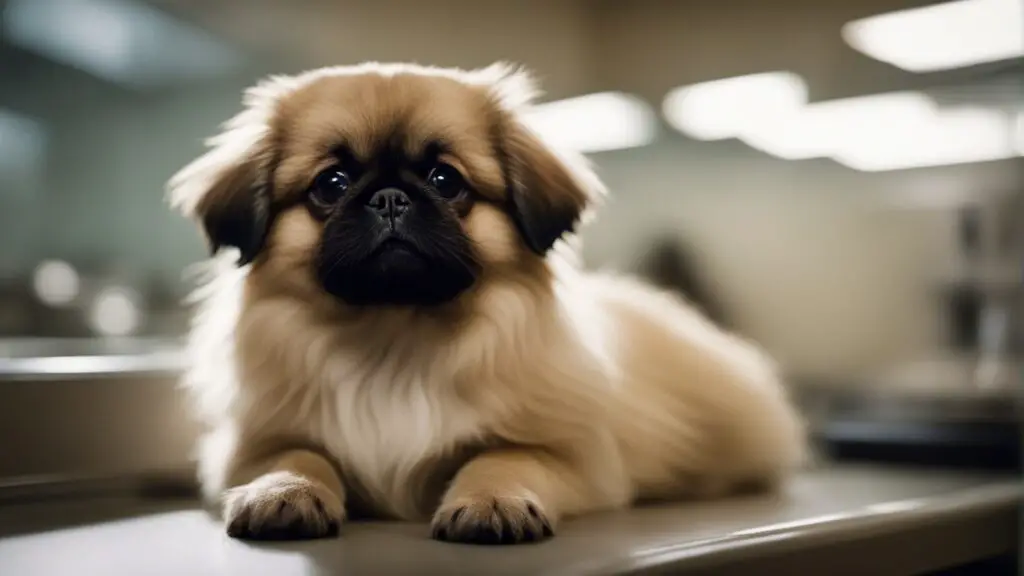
170,65,603,306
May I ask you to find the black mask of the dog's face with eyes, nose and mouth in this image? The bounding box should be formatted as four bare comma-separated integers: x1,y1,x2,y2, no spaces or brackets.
306,136,480,304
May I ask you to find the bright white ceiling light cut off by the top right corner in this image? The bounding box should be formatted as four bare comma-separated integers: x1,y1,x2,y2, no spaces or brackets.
842,0,1024,72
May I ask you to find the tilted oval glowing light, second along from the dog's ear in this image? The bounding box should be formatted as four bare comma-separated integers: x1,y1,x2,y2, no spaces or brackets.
662,72,807,140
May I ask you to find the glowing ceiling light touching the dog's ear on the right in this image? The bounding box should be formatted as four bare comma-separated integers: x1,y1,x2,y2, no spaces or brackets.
524,92,657,154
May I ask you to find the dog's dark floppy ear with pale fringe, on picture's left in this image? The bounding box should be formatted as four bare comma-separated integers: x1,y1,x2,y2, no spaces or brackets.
167,78,291,265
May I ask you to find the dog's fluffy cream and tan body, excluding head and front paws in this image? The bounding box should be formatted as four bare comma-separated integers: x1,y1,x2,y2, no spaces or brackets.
186,249,803,520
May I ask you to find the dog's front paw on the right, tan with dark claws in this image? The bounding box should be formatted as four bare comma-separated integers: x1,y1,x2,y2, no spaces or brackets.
431,496,554,544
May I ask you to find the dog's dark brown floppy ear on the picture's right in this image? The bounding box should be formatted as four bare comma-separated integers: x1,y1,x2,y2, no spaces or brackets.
484,65,605,255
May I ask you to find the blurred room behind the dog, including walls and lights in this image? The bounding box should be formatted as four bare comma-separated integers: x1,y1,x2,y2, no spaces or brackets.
0,0,1024,487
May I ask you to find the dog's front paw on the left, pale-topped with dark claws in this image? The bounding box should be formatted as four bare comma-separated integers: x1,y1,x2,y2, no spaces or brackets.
223,471,344,540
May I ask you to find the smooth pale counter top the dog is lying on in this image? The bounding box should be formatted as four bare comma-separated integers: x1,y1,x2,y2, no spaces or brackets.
0,465,1024,576
